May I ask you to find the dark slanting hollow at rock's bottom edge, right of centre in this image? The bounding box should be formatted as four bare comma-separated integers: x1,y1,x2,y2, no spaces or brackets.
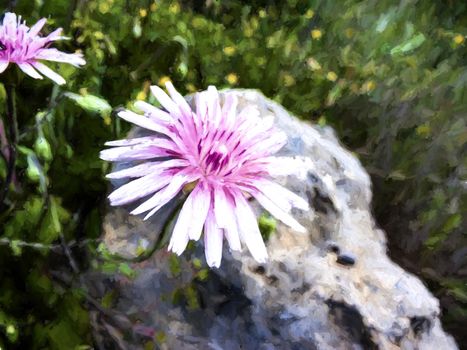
326,299,378,350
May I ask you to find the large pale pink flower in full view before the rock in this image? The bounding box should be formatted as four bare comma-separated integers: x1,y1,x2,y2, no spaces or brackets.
100,82,308,267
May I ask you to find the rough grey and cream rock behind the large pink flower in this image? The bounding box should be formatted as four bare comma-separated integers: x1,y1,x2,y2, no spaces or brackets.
97,90,457,350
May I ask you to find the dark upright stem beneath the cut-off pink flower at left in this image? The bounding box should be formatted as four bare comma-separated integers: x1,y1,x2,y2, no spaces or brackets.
0,83,18,209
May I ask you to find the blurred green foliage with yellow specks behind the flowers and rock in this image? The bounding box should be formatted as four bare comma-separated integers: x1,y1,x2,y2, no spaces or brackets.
0,0,467,349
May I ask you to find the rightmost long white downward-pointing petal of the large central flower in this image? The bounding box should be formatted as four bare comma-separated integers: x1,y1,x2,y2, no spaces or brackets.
234,191,268,263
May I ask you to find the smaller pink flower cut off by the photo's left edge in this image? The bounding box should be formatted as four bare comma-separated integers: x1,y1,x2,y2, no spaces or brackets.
0,12,86,85
